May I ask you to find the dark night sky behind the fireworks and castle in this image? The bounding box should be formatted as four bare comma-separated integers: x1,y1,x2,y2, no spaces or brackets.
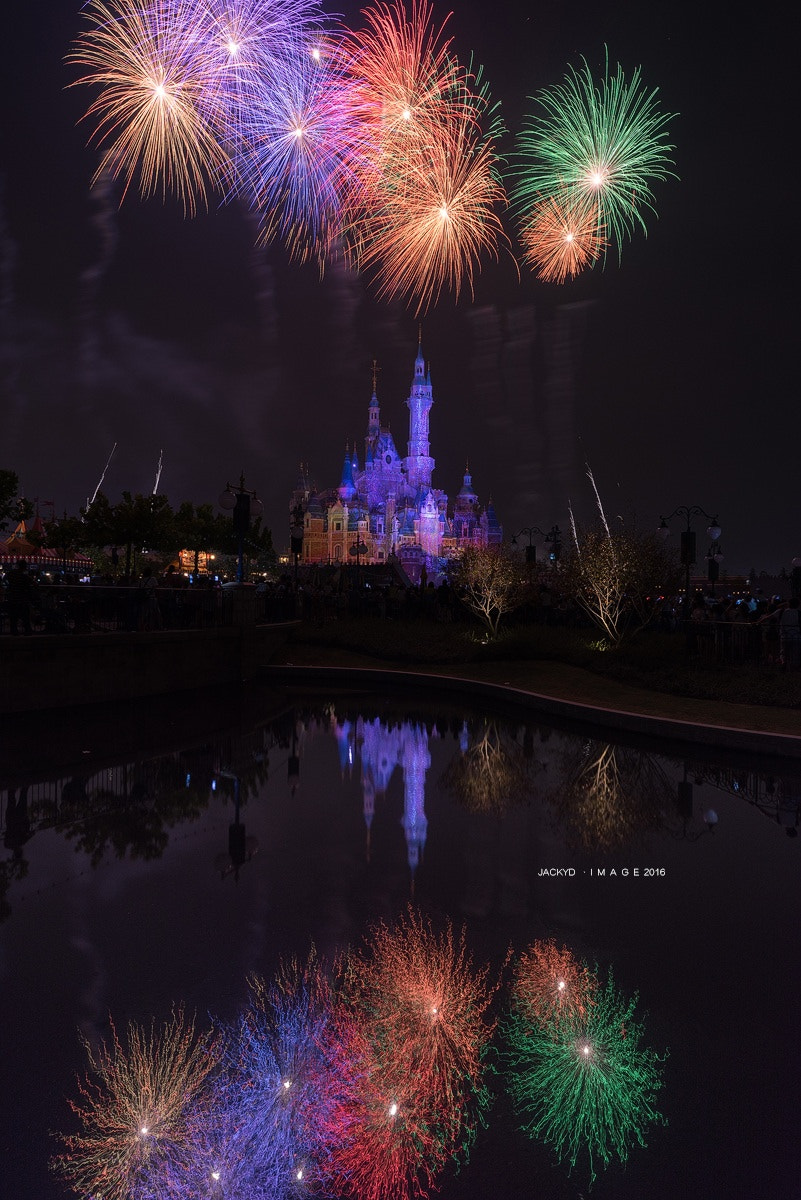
0,0,801,572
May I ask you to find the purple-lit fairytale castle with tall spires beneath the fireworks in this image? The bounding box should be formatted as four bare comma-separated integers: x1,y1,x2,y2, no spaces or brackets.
290,346,502,582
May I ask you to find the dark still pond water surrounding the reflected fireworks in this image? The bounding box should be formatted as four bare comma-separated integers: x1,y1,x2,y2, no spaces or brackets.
0,691,801,1200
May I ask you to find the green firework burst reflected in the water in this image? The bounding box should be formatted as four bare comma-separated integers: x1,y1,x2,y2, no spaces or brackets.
506,974,664,1180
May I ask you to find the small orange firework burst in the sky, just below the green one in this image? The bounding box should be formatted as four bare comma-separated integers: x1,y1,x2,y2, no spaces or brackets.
520,193,607,283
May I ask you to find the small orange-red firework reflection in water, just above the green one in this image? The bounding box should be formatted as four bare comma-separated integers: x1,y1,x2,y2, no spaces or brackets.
512,938,596,1032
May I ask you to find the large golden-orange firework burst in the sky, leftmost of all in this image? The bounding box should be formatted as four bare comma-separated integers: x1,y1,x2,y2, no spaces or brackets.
67,0,230,214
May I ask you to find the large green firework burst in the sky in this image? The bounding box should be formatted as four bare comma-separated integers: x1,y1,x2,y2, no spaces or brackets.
512,55,676,261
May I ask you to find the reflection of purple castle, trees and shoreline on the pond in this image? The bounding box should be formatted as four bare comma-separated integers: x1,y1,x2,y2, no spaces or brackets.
0,701,801,919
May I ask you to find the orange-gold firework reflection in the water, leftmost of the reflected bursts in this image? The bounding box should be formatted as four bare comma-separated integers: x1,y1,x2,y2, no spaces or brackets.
53,1008,217,1200
